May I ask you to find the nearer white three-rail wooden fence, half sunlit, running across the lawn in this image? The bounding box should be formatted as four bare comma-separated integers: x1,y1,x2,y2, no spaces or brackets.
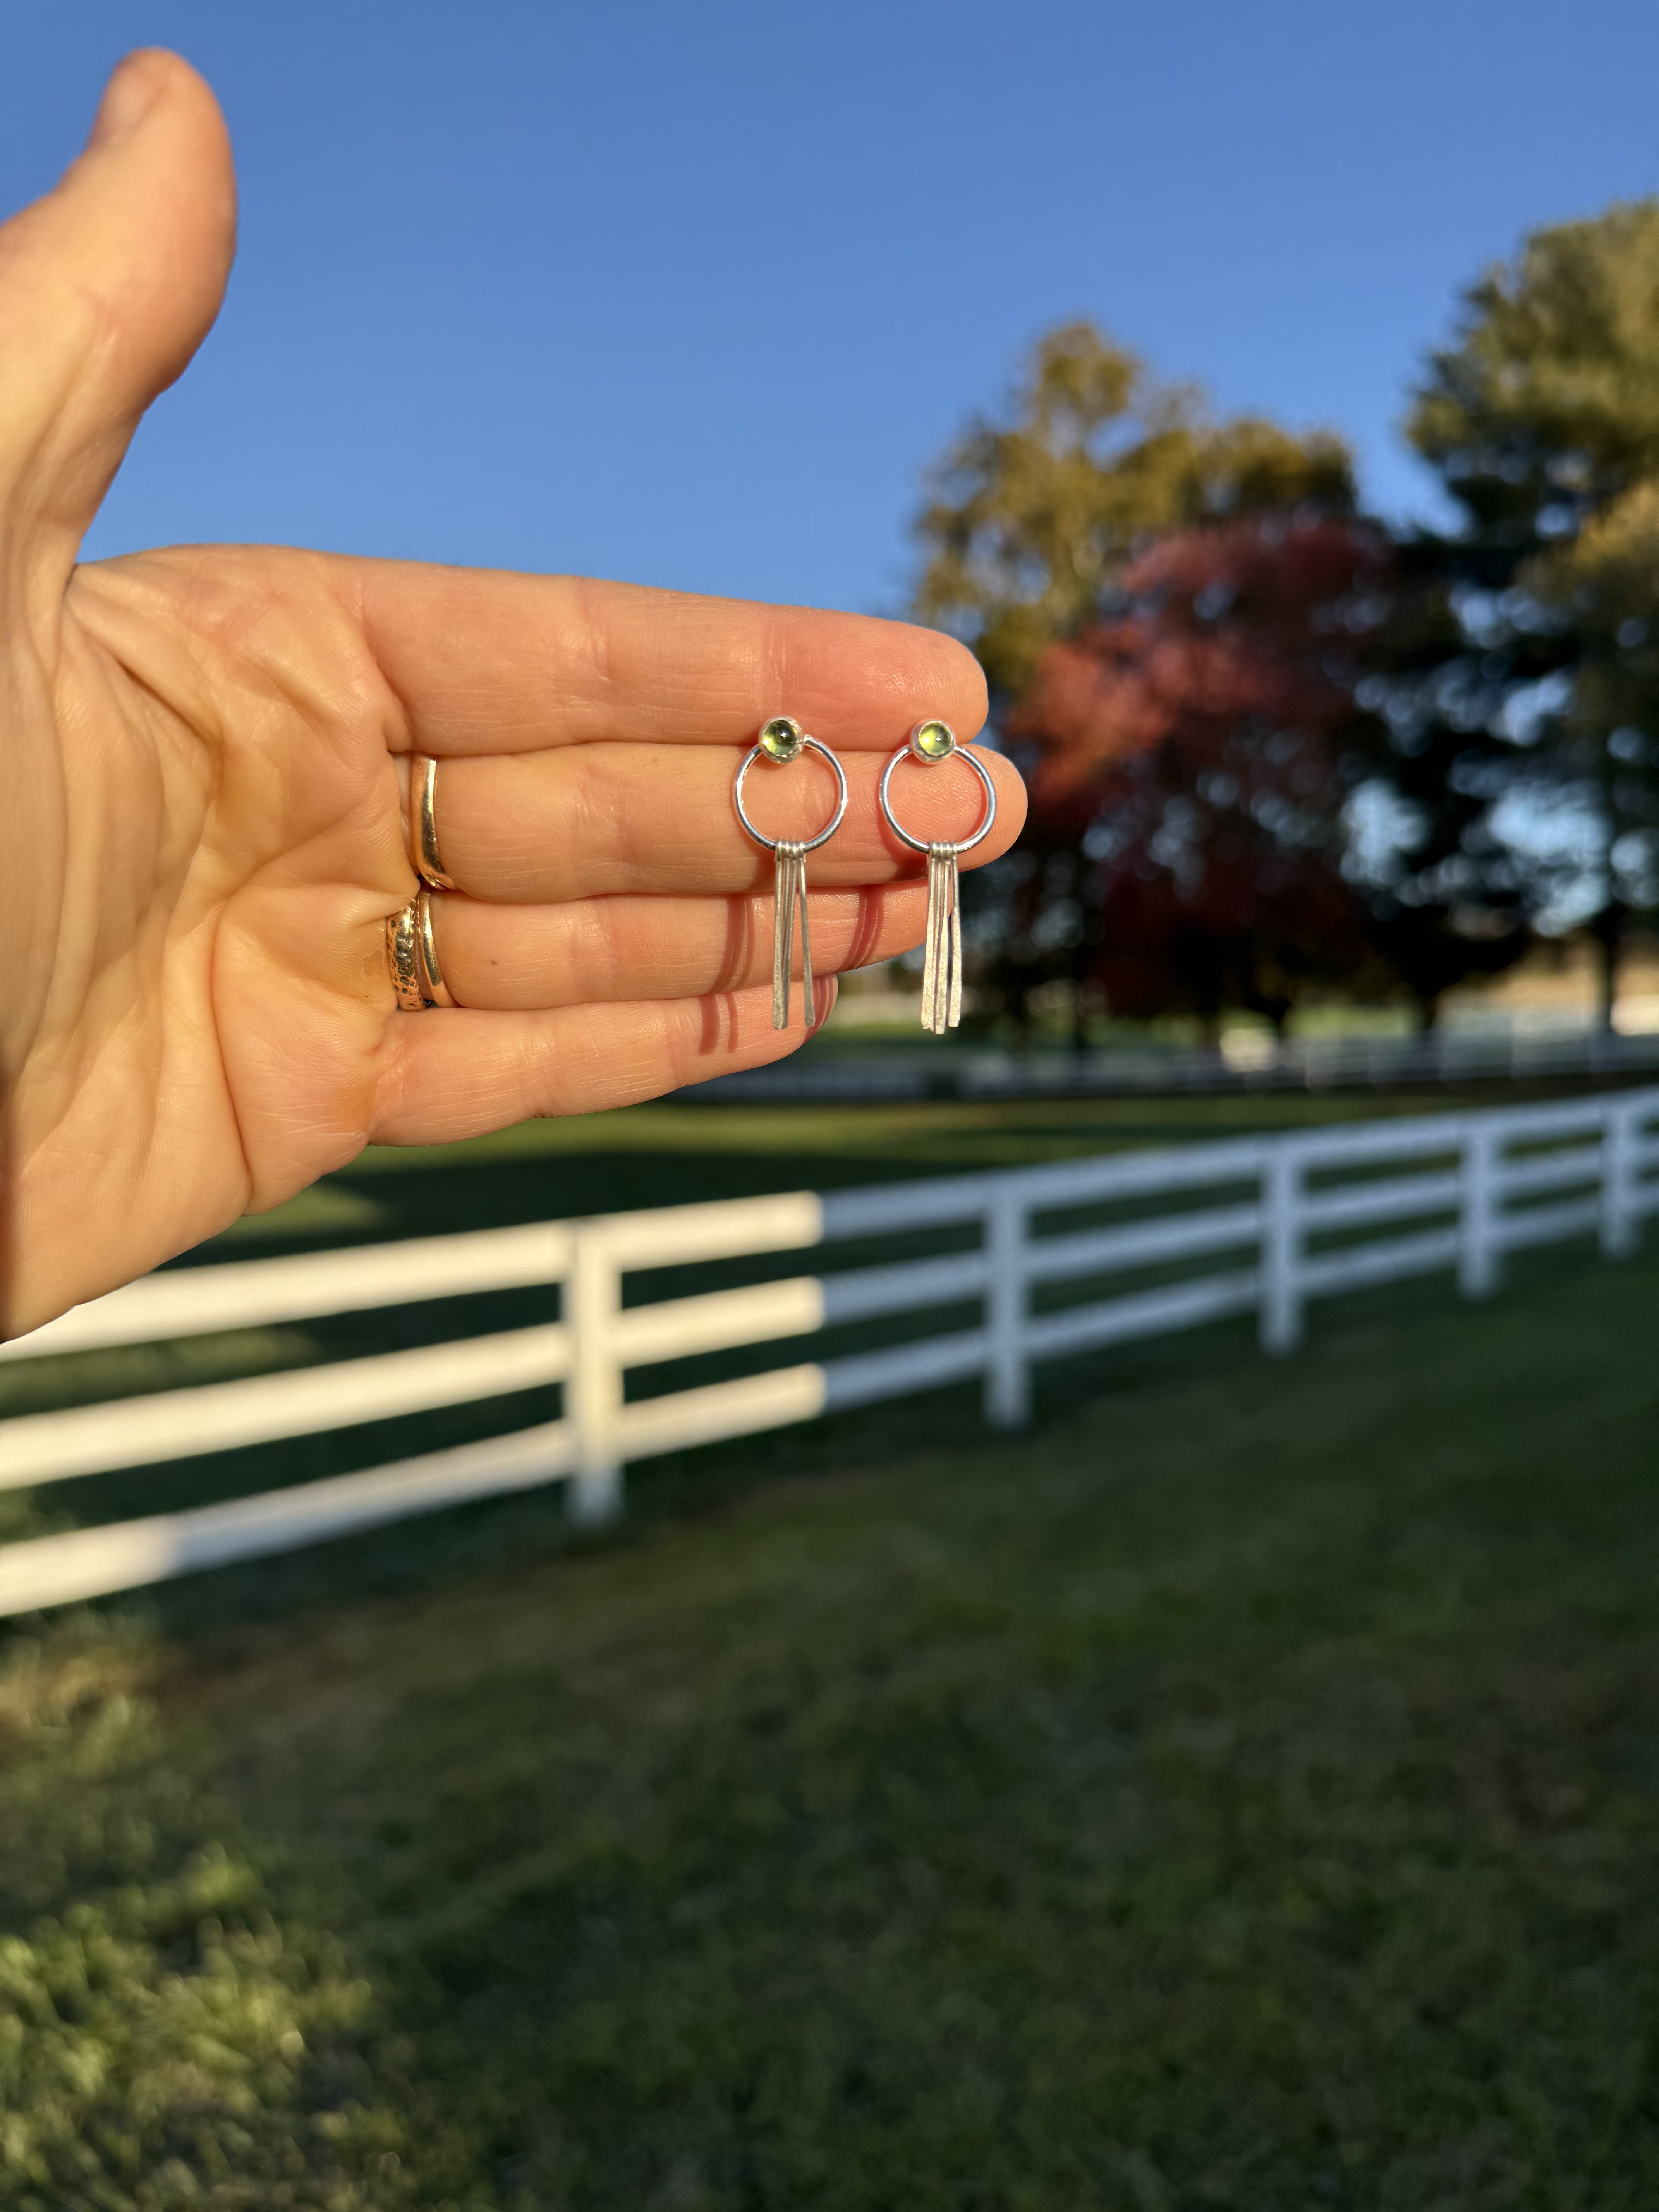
0,1088,1659,1613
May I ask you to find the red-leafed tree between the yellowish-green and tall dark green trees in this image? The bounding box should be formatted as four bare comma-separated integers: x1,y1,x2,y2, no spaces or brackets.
1002,518,1387,1029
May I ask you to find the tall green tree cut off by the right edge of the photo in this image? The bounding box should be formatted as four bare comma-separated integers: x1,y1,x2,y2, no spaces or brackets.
1376,199,1659,1020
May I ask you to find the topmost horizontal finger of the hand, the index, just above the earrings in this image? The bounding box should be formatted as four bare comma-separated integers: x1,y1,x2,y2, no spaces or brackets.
338,557,987,757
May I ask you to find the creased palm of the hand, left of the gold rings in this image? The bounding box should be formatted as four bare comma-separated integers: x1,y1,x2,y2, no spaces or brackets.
38,551,409,1290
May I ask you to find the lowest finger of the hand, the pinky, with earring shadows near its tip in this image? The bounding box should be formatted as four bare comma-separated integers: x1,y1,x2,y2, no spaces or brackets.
369,975,836,1144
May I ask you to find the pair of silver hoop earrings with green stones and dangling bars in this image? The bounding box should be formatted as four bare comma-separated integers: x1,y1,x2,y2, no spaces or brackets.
732,714,998,1037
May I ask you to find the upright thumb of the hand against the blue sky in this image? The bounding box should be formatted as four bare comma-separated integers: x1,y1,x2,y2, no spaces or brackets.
0,49,237,584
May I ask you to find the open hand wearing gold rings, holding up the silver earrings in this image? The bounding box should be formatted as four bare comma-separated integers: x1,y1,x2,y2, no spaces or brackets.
0,53,1024,1334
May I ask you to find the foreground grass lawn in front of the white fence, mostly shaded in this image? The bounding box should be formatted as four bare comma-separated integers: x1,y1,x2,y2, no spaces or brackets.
0,1238,1659,2212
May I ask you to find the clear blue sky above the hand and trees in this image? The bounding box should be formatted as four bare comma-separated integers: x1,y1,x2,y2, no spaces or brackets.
0,0,1659,611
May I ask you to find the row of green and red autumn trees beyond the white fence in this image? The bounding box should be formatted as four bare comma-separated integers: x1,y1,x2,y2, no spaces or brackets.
916,199,1659,1029
